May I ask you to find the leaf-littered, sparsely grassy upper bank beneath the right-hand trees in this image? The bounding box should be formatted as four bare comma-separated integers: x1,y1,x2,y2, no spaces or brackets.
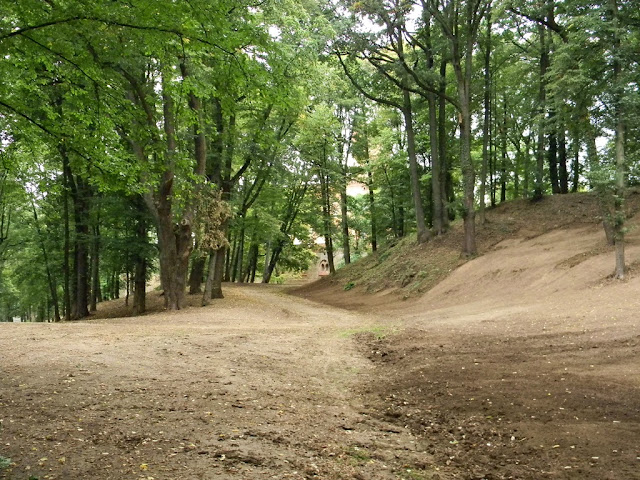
294,189,640,308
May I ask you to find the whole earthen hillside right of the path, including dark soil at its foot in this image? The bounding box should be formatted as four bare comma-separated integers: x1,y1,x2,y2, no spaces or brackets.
298,195,640,480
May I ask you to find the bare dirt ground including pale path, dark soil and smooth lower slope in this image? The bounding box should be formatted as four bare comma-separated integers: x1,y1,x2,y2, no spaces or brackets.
0,193,640,480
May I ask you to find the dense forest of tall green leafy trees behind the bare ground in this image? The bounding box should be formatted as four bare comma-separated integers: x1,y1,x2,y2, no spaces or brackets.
0,0,640,321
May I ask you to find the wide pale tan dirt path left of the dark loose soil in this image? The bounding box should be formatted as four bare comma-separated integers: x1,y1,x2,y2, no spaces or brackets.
0,287,436,480
